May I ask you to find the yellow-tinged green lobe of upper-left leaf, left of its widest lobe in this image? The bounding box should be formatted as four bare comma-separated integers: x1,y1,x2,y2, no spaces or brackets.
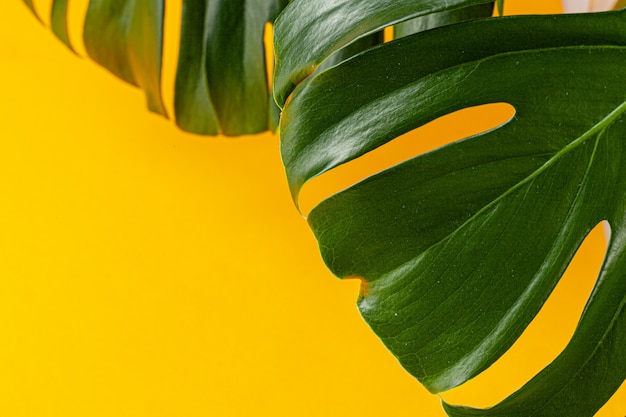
84,0,167,116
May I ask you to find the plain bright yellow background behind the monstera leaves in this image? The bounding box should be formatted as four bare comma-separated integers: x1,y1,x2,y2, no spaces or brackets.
0,0,626,417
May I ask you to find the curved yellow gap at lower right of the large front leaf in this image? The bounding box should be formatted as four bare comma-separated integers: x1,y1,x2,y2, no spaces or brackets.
441,222,610,408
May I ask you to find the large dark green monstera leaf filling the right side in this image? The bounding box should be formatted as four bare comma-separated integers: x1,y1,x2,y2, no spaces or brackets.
277,7,626,417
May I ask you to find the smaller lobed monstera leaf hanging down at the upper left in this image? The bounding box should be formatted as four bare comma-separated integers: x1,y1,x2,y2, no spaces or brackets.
23,0,289,135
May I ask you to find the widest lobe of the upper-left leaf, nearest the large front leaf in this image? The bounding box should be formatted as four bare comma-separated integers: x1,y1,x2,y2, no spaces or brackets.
175,0,287,135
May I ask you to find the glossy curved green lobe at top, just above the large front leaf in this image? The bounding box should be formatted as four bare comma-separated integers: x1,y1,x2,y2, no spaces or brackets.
274,0,493,107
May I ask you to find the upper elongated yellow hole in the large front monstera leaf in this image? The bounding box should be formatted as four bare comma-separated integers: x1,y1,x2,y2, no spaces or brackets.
299,103,515,215
